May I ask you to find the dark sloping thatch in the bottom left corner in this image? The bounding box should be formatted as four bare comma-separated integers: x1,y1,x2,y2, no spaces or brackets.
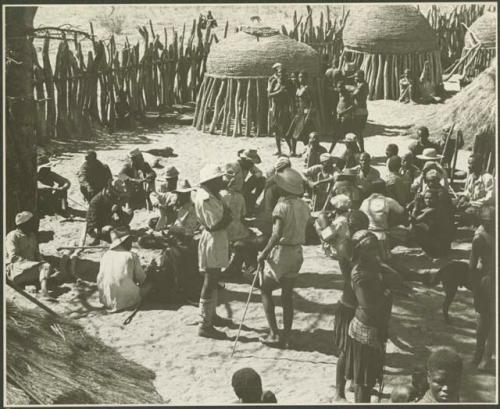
6,302,162,405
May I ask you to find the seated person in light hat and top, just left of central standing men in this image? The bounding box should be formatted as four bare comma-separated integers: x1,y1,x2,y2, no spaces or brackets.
149,166,179,231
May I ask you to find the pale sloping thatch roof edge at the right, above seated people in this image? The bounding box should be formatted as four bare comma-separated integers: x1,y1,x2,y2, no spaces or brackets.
416,60,497,147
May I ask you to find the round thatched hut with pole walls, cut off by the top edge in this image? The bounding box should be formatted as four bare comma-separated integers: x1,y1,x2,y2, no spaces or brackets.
341,4,442,99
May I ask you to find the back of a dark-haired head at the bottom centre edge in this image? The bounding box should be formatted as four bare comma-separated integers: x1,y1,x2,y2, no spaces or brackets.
231,368,277,403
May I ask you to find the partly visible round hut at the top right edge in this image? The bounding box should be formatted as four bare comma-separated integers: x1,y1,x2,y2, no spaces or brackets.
461,12,497,78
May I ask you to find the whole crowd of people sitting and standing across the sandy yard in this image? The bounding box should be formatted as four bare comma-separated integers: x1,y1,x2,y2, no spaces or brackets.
6,59,496,402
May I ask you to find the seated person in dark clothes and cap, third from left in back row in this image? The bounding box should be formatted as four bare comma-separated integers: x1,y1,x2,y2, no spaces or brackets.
118,149,156,210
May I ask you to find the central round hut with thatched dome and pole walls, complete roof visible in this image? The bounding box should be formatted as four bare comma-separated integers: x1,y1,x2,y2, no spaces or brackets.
193,27,323,136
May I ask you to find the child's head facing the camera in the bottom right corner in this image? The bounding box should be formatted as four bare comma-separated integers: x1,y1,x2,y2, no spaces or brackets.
418,347,463,404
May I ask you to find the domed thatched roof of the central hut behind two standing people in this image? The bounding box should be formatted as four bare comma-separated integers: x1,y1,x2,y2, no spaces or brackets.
207,27,320,78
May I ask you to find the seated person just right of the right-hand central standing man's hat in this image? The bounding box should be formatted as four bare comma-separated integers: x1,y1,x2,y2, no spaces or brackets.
303,153,337,211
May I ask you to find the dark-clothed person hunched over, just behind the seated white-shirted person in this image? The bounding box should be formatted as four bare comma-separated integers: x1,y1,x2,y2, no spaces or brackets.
86,181,134,246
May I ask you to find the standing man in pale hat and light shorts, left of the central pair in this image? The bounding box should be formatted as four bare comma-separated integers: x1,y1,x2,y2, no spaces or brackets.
194,165,231,339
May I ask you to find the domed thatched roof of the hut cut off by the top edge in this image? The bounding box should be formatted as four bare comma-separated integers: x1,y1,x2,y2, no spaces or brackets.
343,4,438,54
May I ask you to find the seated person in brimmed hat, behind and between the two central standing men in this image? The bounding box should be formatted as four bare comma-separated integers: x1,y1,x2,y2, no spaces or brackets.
226,149,266,215
